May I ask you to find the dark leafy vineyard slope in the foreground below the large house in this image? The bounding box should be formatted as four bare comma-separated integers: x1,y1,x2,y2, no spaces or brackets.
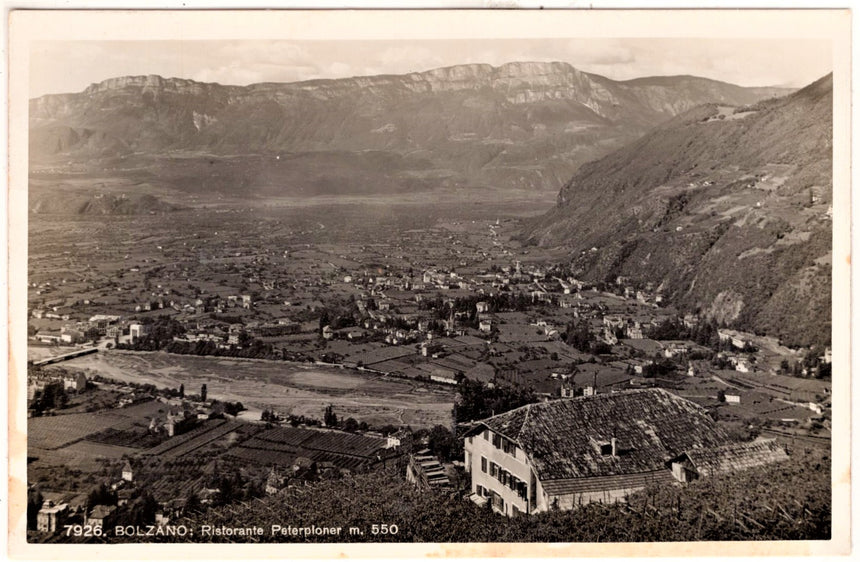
133,444,831,542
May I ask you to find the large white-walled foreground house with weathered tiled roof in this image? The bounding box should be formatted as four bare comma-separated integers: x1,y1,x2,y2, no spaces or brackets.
465,389,729,515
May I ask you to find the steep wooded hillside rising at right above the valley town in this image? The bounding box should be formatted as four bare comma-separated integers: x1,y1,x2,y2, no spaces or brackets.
525,76,833,345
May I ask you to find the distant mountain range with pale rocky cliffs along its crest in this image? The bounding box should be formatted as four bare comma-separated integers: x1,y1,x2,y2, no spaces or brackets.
30,62,778,195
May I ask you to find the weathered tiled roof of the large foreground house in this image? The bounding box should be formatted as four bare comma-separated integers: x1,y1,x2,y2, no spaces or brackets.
470,389,728,482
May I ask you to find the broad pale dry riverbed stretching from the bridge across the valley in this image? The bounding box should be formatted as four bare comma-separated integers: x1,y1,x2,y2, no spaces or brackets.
55,352,454,429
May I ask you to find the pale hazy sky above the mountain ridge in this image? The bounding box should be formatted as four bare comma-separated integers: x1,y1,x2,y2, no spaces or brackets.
29,38,832,97
